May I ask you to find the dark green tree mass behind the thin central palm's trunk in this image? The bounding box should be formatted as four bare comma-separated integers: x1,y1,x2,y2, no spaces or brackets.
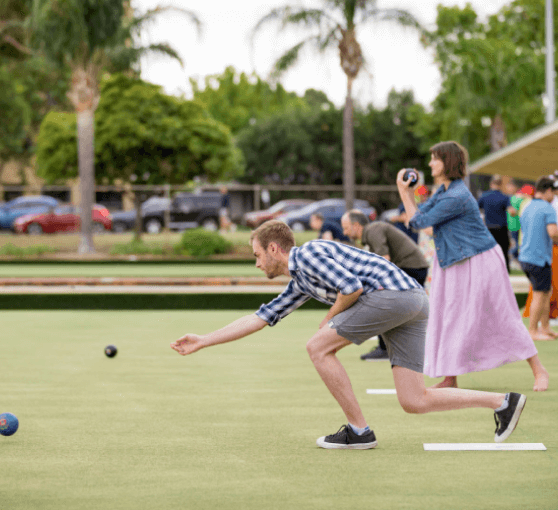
237,91,428,188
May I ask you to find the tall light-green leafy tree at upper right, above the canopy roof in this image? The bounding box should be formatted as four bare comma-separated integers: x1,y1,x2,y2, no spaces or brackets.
423,0,558,159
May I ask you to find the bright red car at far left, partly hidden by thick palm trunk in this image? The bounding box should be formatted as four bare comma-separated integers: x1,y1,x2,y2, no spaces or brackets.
14,204,112,234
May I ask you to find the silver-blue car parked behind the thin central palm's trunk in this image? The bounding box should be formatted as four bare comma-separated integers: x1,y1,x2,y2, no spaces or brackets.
277,198,377,232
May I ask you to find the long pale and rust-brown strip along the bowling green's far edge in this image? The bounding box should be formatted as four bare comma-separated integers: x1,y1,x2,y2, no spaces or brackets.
0,276,529,294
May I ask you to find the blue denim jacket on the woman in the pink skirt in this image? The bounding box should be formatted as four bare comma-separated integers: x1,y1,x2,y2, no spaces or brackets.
409,179,496,269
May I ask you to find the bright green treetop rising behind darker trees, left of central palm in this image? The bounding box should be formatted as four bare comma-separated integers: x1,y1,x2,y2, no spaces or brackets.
190,66,307,133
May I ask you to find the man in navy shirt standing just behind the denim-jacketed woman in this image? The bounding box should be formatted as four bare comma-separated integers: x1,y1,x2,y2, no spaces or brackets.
479,175,517,273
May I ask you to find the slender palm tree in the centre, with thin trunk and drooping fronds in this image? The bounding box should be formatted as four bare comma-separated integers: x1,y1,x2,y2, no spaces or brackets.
253,0,420,209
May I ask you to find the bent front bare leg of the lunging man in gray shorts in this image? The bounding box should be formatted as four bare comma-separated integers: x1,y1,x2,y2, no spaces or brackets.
306,325,367,428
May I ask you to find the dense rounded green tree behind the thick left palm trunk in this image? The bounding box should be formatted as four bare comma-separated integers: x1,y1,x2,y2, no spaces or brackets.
37,74,243,240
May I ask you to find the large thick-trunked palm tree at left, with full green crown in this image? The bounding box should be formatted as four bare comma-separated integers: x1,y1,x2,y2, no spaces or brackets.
29,0,201,253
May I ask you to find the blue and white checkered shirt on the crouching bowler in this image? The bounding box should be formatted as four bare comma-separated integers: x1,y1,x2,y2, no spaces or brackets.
256,240,422,326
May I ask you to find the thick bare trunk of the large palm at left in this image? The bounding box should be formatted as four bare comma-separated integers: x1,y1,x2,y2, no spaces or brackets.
77,110,95,253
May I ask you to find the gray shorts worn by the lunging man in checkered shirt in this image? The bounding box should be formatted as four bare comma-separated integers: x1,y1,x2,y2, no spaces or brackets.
328,289,428,373
